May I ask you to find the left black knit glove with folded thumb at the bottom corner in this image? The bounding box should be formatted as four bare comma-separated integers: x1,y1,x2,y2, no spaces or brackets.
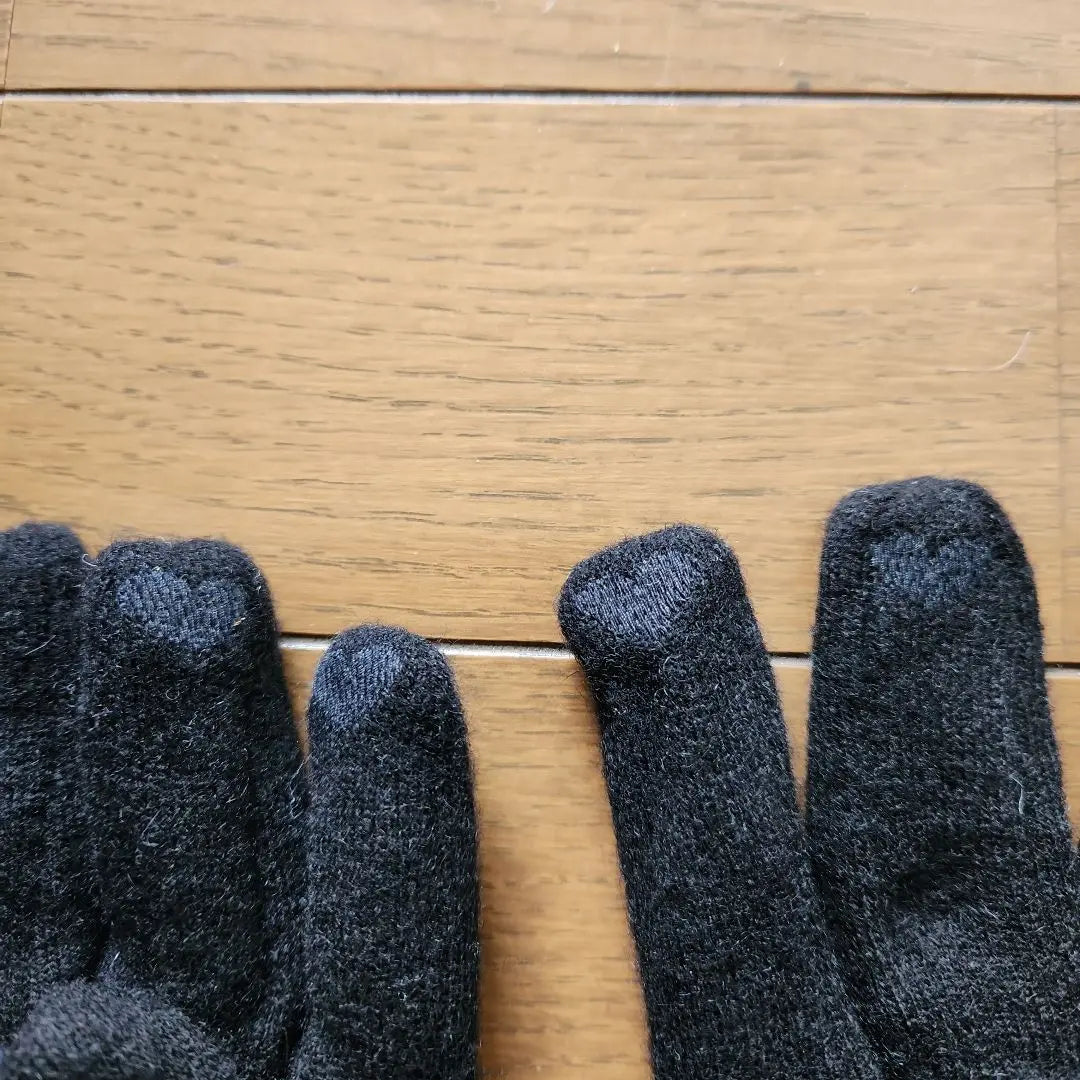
0,525,478,1080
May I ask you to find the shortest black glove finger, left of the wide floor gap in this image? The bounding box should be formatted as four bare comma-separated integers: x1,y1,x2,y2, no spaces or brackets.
297,626,480,1080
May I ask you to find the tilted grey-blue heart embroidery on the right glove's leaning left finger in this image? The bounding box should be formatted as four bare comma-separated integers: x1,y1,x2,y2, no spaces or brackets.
572,551,705,648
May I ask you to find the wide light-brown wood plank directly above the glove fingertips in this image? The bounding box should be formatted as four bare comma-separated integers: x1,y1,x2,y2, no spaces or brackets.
0,99,1064,657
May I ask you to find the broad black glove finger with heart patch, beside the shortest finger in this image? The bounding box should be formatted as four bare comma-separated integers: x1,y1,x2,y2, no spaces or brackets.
83,540,303,1076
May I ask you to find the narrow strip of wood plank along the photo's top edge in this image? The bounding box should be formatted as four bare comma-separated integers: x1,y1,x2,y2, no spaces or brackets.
11,0,1080,94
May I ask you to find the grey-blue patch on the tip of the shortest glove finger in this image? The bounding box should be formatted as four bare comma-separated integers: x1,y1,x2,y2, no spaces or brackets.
312,629,405,725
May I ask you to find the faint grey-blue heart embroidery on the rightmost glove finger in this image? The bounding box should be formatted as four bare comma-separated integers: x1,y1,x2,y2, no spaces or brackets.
870,532,990,607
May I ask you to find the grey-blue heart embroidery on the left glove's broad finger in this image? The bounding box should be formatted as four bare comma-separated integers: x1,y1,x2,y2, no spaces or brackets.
117,569,247,650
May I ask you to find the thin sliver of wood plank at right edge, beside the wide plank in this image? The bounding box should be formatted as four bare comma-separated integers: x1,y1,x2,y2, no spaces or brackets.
1056,108,1080,654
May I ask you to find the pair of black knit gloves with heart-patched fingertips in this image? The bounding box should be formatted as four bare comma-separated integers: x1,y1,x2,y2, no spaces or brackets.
0,478,1080,1080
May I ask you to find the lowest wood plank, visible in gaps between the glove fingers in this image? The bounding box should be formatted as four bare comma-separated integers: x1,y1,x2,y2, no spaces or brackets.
285,649,1080,1080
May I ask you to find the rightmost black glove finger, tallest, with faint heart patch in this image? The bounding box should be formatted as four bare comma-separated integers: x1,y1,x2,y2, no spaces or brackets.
807,477,1080,1078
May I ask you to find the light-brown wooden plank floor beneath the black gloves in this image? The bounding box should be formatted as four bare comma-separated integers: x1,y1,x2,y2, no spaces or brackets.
0,0,1080,1080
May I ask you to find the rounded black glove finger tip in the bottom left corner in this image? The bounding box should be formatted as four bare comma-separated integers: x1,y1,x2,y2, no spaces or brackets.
0,982,237,1080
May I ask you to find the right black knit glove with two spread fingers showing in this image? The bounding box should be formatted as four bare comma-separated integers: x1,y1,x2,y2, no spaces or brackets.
559,478,1080,1080
